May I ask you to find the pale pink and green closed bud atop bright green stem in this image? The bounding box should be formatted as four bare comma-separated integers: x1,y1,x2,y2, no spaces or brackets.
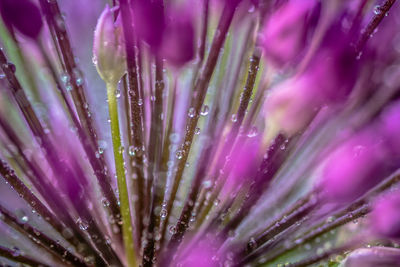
93,5,126,84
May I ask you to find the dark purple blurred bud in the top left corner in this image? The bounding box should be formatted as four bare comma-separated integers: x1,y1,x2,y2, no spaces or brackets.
0,0,43,39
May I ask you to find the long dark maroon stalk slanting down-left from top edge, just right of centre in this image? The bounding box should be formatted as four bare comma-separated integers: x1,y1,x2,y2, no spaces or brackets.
162,1,241,248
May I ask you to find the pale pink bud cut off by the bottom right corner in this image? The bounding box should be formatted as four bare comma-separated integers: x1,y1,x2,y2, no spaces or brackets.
339,247,400,267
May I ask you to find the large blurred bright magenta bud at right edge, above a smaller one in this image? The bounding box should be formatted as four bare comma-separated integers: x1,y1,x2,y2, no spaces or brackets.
323,103,400,202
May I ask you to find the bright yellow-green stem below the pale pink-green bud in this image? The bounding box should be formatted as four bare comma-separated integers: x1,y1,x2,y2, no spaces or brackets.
106,83,138,267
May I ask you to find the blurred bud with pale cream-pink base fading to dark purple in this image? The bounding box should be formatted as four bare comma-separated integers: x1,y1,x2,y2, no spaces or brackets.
264,27,359,136
